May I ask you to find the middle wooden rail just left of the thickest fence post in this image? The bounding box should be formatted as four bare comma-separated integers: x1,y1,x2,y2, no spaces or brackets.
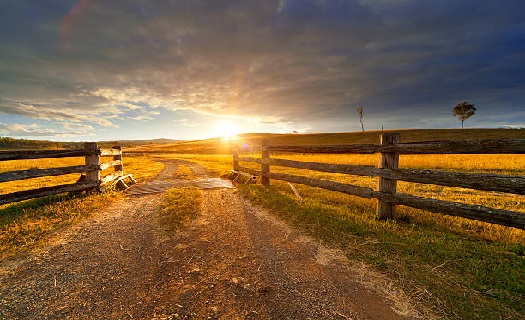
270,159,381,177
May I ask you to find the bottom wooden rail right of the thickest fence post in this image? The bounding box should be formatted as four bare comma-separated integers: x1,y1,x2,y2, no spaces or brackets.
373,191,525,230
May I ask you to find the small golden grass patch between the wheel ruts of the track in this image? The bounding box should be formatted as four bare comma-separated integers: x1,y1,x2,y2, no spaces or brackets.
158,187,202,234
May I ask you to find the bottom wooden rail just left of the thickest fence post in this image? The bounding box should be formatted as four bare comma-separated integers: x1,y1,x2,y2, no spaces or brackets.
270,172,374,198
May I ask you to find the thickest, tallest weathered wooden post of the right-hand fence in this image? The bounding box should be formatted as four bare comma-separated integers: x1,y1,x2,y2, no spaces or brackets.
377,132,400,220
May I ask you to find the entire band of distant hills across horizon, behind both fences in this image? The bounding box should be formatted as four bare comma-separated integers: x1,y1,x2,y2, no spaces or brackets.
0,129,525,154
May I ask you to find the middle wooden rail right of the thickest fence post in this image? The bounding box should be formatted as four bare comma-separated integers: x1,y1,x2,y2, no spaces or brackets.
378,169,525,195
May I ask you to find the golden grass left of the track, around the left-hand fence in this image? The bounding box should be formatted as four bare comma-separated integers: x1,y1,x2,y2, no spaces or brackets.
0,157,163,261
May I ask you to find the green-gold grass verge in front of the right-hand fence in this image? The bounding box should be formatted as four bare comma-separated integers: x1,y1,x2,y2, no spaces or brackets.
240,183,525,319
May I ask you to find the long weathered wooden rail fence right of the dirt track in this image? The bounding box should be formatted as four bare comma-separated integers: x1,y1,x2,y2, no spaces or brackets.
233,133,525,230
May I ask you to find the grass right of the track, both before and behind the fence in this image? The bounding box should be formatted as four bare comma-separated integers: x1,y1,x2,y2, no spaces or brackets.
162,154,525,319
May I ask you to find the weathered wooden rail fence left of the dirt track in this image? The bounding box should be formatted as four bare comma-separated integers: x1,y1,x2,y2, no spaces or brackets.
0,142,124,205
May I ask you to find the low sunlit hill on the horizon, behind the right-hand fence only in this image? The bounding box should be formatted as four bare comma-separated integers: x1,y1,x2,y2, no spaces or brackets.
124,129,525,154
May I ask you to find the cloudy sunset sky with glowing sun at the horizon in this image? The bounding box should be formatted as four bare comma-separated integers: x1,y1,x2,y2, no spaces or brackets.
0,0,525,141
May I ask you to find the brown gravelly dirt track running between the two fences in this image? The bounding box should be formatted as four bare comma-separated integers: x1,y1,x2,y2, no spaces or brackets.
0,162,422,319
